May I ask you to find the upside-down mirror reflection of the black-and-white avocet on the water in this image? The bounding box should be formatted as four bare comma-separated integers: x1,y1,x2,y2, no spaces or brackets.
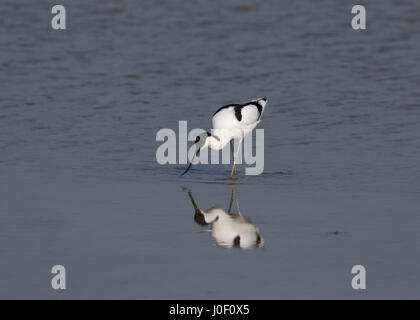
186,184,264,249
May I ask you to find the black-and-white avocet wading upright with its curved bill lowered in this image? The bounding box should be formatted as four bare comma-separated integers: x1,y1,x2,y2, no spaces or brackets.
182,98,267,179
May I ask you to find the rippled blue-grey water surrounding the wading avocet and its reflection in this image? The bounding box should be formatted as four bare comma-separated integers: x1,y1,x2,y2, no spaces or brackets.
0,0,420,299
